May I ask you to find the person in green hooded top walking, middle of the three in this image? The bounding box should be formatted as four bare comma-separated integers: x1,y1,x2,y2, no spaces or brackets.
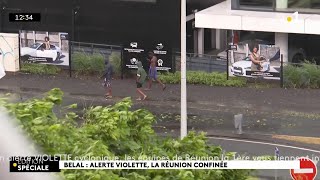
145,51,166,90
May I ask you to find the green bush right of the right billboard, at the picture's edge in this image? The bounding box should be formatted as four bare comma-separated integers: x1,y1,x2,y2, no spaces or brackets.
283,63,320,88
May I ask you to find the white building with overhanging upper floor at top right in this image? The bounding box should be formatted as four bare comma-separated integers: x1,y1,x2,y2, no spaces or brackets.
195,0,320,61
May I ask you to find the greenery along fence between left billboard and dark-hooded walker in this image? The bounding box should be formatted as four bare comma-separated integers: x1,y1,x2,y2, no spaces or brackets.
72,52,105,75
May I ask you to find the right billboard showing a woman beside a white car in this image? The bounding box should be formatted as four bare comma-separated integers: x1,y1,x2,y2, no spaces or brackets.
228,44,281,80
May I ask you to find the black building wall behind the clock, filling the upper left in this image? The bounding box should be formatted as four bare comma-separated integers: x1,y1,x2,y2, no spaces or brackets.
0,0,221,49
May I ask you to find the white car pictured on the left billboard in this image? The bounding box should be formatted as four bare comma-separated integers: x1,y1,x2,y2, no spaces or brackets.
20,43,62,62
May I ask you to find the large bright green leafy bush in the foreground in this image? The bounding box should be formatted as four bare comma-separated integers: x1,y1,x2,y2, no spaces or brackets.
3,89,251,180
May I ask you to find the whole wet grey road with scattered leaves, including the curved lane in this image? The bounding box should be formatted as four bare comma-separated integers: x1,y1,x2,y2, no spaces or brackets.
0,75,320,180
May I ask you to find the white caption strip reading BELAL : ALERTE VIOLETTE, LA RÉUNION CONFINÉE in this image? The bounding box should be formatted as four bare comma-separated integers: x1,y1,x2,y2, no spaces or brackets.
59,160,300,169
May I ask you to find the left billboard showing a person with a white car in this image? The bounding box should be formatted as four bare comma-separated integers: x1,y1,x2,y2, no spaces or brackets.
20,30,70,66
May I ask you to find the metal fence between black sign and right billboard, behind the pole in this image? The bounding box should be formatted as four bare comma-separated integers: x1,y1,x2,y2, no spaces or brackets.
173,52,227,72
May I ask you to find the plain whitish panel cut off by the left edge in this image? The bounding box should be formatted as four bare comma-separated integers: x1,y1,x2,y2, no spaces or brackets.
0,33,19,77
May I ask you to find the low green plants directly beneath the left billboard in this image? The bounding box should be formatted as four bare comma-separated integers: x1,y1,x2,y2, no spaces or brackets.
21,63,61,75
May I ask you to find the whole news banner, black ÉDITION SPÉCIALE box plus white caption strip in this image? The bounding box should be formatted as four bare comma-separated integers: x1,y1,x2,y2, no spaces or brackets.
10,156,312,172
